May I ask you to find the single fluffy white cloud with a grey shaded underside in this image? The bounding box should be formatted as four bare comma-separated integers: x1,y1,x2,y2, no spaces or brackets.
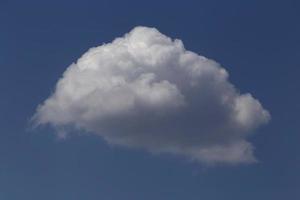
33,27,270,164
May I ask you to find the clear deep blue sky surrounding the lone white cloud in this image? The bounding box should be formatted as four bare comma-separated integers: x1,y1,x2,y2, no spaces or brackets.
0,0,300,200
